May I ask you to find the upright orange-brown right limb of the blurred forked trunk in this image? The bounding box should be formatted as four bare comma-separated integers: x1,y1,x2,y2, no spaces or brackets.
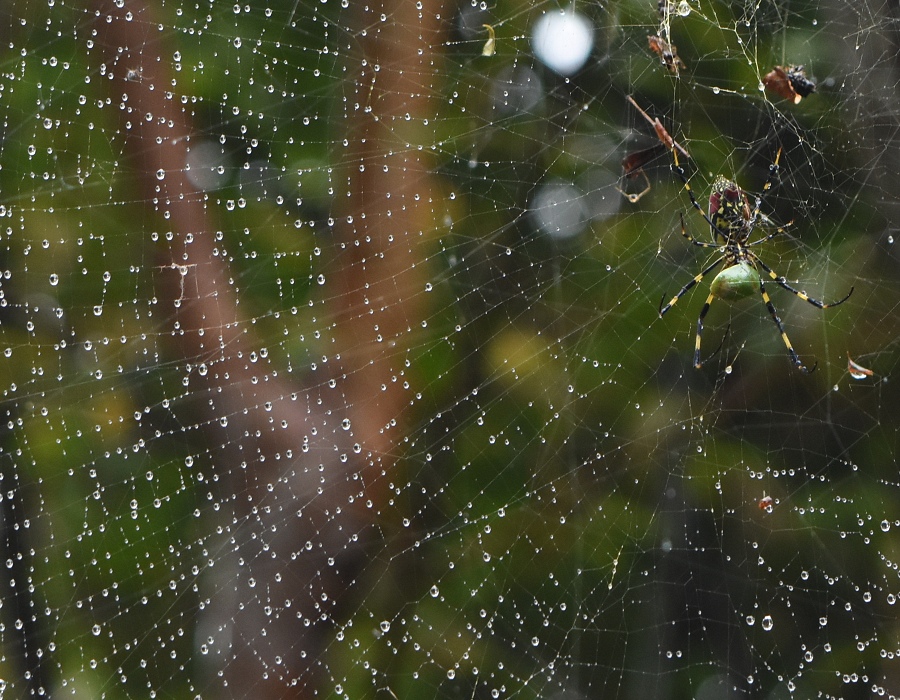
332,0,443,508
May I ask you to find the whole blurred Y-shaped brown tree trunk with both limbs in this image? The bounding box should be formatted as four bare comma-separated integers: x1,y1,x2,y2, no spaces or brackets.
95,0,442,698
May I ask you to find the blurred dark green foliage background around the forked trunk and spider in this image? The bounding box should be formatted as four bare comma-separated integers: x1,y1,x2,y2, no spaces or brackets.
0,1,900,698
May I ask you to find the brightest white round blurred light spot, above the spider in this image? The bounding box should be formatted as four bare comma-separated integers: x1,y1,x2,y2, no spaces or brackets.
531,12,594,75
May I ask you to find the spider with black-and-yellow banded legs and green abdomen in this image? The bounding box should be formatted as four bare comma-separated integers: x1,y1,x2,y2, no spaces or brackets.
659,148,853,374
